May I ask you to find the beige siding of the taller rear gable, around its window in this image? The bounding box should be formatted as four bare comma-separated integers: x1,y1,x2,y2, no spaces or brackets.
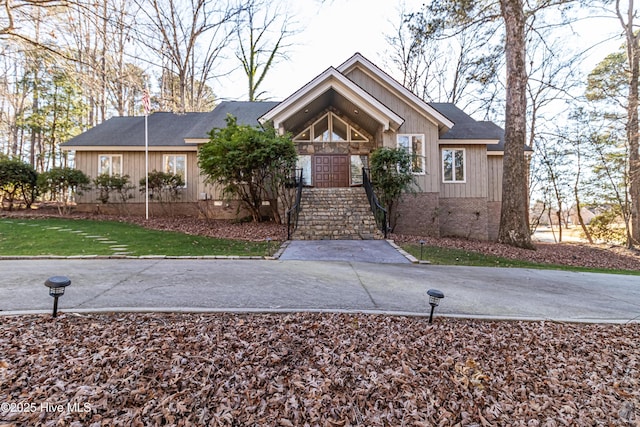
347,68,440,193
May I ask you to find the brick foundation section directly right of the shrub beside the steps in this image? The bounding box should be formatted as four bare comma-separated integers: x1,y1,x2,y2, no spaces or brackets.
393,193,440,237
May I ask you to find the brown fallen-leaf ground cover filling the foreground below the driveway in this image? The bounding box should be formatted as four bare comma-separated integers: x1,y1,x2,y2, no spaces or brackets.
0,313,640,427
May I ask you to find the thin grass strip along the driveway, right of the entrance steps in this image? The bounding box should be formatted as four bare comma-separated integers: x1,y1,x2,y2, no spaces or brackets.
402,244,640,276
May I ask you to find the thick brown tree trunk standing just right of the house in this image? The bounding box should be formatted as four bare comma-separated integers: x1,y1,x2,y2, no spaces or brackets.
498,0,535,249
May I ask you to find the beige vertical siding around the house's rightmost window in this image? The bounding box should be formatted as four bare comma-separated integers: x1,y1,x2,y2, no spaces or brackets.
438,144,489,198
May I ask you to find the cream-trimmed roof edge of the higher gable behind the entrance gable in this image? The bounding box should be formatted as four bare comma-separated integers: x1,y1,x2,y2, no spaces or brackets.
337,53,453,129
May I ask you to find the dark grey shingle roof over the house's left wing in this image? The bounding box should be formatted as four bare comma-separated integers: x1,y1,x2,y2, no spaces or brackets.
62,101,277,147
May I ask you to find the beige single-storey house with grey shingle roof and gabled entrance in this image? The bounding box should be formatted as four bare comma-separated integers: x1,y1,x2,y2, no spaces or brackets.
62,54,504,240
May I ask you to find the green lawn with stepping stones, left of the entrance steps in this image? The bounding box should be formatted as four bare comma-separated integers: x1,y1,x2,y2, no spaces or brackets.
0,218,276,256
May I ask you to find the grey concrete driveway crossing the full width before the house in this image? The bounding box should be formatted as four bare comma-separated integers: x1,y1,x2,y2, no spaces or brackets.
0,259,640,323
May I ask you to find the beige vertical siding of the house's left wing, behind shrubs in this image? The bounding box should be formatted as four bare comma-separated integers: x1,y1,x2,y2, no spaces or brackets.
75,150,219,203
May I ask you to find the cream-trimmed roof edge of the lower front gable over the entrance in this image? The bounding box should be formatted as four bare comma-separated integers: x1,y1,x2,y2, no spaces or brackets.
260,67,404,130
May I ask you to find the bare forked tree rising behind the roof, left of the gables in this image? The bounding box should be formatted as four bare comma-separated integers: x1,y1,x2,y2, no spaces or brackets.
235,0,295,101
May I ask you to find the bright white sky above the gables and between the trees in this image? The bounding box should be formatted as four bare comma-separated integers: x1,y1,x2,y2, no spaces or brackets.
214,0,621,101
